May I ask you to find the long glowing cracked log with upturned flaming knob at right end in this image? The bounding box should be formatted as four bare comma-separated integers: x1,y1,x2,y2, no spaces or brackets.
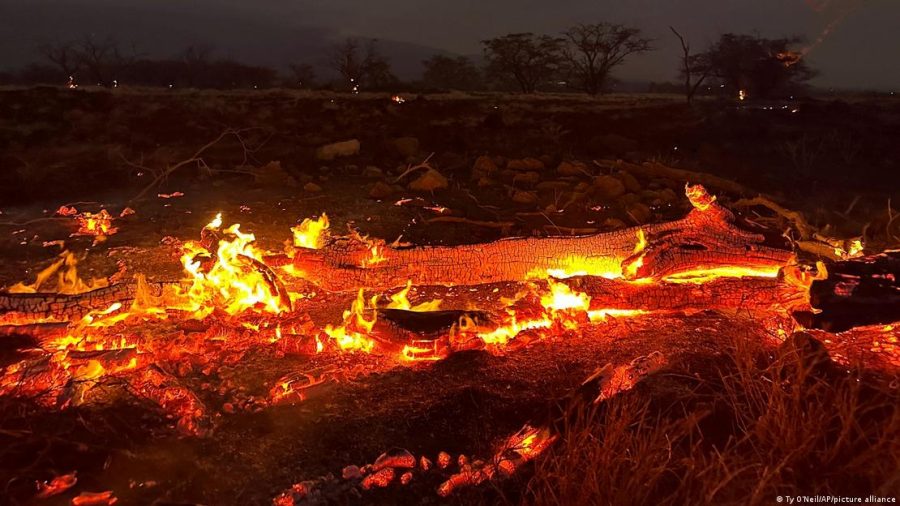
292,186,792,291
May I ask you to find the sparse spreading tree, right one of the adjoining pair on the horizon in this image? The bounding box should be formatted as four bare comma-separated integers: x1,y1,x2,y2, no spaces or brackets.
563,23,653,95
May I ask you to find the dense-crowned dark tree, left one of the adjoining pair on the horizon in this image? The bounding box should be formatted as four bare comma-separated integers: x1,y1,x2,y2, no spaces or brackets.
481,33,563,93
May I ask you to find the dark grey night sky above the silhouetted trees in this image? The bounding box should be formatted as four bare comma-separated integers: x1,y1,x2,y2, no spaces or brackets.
0,0,900,89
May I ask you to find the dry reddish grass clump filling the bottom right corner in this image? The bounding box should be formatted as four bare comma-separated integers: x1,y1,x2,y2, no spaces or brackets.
524,341,900,505
